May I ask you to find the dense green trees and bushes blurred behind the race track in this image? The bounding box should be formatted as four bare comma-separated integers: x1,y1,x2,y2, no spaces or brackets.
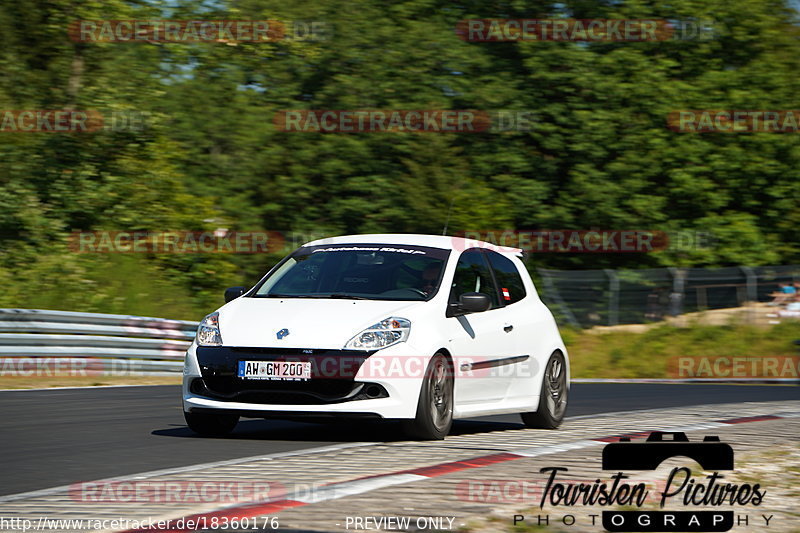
0,0,800,319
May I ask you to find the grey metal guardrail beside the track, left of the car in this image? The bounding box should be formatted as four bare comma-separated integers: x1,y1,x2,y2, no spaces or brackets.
0,309,197,375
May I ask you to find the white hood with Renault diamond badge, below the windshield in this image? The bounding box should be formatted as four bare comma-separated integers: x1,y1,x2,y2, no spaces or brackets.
219,298,424,350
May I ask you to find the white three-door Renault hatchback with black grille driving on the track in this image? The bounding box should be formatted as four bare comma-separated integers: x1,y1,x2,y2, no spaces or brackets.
183,235,569,439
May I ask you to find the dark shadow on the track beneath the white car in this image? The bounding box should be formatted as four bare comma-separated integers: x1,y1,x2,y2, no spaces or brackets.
151,420,523,443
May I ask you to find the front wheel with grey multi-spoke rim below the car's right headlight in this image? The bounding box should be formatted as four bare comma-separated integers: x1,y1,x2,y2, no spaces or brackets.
404,353,453,440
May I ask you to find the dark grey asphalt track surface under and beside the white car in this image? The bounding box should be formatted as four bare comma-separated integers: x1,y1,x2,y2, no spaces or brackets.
0,383,800,495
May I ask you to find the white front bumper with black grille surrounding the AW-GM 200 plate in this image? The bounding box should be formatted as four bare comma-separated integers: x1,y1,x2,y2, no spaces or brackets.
183,344,421,418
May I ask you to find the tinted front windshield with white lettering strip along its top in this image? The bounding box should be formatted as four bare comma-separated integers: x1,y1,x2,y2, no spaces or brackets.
254,244,450,300
